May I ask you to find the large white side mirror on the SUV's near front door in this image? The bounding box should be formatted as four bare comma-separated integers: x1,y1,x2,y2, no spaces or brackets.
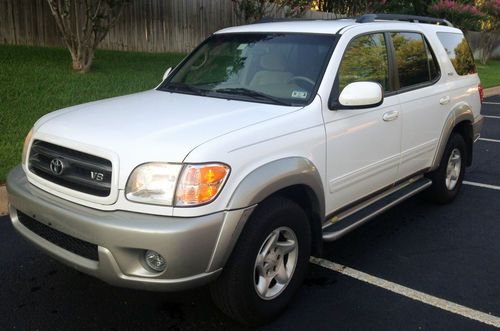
338,82,384,108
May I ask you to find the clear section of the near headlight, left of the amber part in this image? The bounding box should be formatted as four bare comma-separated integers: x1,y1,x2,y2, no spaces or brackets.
125,163,182,206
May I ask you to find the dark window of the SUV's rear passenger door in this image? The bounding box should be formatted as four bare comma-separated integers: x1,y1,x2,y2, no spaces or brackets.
391,32,439,88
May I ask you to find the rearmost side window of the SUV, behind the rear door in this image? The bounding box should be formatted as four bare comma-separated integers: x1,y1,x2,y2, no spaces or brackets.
437,32,476,76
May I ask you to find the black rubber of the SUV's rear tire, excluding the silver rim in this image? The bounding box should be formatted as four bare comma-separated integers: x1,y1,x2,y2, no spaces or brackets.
425,132,467,204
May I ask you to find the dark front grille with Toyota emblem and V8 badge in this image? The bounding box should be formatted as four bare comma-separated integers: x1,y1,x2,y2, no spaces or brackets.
28,140,112,197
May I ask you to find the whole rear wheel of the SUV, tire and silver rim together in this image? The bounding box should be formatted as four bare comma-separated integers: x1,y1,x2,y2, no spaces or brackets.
426,133,467,204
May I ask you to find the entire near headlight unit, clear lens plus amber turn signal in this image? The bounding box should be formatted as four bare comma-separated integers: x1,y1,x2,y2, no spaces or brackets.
125,163,229,206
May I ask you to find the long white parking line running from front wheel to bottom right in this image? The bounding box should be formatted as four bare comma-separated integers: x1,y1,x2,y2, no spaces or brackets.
311,257,500,328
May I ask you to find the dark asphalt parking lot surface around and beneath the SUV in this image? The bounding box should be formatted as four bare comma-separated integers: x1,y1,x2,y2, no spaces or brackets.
0,96,500,330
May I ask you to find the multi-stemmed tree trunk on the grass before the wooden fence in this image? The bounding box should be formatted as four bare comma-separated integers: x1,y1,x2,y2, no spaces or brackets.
47,0,128,73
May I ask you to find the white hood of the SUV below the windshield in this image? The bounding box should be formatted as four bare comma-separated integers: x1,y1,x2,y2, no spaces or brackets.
35,90,299,186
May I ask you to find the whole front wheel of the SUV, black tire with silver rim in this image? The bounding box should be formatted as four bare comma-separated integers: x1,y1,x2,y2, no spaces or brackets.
210,197,311,325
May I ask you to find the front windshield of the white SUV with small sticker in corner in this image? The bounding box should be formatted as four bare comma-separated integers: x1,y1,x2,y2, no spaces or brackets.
160,33,335,105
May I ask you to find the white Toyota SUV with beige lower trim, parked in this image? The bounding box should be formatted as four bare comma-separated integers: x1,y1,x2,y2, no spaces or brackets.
7,14,482,324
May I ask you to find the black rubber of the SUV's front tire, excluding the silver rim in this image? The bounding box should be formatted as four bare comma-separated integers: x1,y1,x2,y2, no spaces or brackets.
210,196,311,326
